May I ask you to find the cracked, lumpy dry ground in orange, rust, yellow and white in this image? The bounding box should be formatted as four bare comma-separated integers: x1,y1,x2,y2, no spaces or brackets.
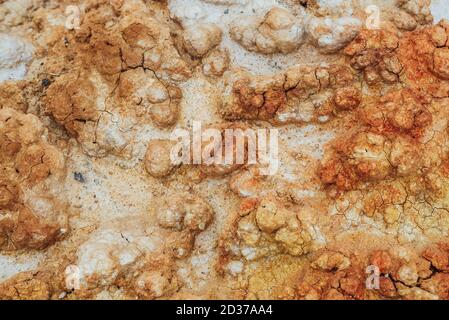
0,0,449,299
